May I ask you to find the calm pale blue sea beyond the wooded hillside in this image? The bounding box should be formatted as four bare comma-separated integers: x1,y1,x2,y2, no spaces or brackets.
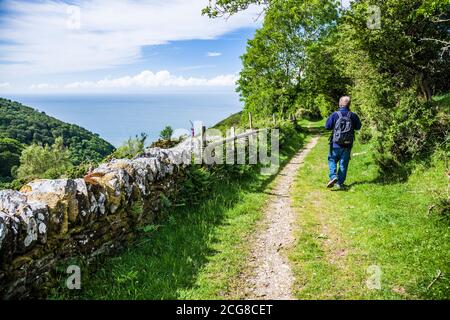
2,92,242,147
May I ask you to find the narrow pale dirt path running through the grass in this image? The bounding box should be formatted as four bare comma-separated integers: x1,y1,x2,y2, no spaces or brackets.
244,136,319,300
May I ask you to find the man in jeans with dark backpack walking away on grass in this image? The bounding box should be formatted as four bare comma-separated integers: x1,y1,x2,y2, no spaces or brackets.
325,96,361,189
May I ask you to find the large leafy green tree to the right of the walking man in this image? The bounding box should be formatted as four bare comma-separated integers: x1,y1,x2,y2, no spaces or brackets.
329,0,450,172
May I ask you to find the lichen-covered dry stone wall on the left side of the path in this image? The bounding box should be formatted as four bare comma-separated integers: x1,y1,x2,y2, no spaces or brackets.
0,140,197,299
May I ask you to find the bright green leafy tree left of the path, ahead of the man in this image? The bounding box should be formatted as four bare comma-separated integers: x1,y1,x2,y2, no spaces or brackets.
238,0,337,117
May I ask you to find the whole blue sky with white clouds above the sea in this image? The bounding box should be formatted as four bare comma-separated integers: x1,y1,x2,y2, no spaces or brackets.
0,0,262,94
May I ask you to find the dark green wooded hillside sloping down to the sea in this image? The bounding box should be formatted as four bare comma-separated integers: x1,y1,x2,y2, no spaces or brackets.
0,98,114,176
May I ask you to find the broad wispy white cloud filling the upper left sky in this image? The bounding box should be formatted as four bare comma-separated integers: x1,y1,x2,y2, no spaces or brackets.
0,0,260,79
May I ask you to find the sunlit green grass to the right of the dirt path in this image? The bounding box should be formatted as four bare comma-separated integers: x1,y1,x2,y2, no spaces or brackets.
290,136,450,299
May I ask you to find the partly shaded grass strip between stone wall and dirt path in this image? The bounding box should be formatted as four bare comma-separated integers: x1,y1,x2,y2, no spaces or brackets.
53,121,304,299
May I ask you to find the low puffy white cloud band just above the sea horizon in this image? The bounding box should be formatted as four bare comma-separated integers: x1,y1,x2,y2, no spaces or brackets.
64,70,237,90
